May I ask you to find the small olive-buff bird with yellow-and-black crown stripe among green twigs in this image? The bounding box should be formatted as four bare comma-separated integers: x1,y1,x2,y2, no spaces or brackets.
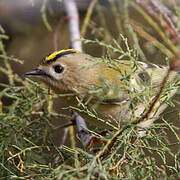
26,49,180,129
